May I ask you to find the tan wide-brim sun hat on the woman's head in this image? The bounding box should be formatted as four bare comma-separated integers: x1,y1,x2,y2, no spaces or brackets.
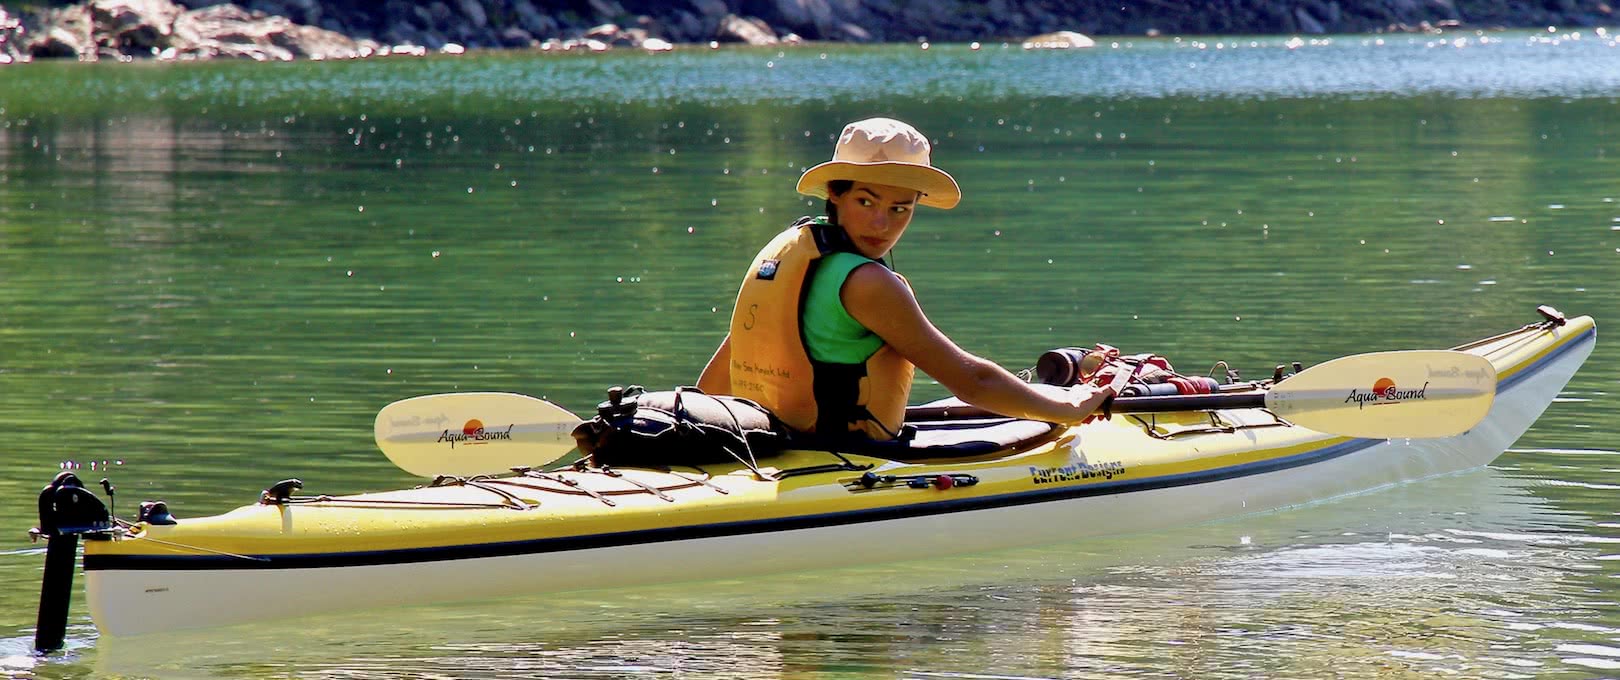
799,118,962,209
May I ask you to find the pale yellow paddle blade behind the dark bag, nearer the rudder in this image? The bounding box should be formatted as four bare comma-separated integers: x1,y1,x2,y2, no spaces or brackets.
376,392,580,478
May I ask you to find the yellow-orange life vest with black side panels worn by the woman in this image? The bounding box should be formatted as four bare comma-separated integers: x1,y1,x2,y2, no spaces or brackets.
731,217,915,440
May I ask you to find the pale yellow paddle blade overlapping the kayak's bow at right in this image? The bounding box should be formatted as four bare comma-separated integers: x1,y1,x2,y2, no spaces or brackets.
1265,350,1497,439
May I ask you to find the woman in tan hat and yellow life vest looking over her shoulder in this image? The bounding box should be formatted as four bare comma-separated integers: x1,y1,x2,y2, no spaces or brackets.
698,118,1115,440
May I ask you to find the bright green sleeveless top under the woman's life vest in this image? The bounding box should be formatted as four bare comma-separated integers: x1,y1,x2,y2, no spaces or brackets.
799,253,883,364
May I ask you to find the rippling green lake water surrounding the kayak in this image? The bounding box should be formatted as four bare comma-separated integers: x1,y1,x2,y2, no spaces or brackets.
0,32,1620,678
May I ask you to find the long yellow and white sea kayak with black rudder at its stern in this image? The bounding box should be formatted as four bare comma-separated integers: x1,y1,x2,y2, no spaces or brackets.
28,308,1597,635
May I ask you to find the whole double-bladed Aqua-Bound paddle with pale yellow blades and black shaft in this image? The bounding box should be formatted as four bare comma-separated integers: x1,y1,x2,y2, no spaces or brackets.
376,350,1497,478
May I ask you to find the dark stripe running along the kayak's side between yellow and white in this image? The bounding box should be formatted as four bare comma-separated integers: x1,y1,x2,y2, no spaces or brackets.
84,323,1596,572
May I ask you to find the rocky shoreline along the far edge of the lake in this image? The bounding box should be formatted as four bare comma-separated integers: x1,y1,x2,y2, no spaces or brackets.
0,0,1620,63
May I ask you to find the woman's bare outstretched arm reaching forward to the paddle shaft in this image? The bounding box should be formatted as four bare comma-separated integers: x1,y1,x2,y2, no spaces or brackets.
839,264,1115,423
